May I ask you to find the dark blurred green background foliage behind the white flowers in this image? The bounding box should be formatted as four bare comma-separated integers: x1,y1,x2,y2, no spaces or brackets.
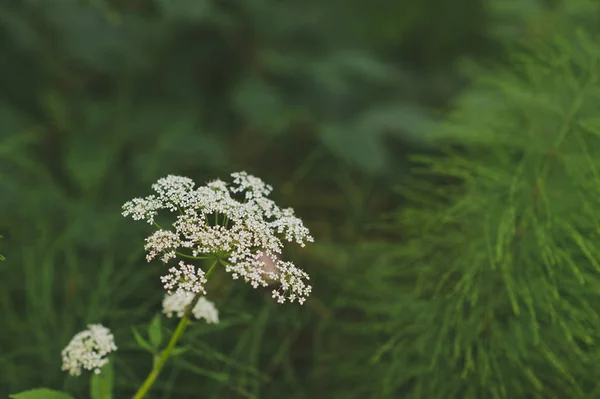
0,0,585,399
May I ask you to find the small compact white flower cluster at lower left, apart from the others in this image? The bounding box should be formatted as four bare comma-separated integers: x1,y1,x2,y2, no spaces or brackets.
61,324,117,376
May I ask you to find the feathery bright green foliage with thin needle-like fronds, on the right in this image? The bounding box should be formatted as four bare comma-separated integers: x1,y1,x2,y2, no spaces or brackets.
330,25,600,399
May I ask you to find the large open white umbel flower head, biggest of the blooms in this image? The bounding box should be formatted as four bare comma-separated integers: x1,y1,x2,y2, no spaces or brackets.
123,172,313,304
